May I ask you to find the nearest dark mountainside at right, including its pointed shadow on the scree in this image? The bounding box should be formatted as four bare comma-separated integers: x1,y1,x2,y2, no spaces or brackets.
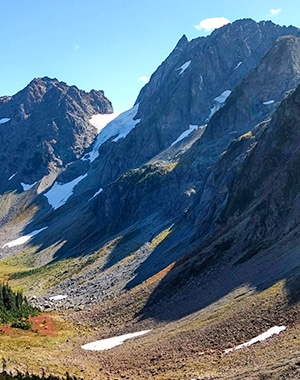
142,80,300,319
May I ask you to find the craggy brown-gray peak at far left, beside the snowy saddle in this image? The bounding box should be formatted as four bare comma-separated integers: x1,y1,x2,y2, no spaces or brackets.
0,77,112,191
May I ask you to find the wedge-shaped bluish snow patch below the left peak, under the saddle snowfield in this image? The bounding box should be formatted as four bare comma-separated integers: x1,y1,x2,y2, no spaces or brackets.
44,174,87,210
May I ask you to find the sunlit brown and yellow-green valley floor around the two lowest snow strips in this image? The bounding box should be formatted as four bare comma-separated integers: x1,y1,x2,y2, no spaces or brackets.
0,281,300,380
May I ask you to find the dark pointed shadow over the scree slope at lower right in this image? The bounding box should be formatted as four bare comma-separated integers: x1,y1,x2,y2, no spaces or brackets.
140,227,300,321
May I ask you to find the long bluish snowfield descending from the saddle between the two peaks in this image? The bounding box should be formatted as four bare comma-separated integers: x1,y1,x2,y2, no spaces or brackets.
82,104,140,162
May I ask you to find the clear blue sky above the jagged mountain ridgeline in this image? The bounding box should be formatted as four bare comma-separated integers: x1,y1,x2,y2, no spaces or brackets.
0,0,300,112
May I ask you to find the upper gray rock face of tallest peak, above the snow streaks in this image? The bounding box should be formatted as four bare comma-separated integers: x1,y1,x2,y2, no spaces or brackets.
137,19,300,135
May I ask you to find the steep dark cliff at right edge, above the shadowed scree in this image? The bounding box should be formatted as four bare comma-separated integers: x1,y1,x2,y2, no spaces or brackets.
221,86,300,252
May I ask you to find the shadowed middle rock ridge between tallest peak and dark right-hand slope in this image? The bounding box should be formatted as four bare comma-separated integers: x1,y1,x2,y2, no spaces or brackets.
92,32,300,246
